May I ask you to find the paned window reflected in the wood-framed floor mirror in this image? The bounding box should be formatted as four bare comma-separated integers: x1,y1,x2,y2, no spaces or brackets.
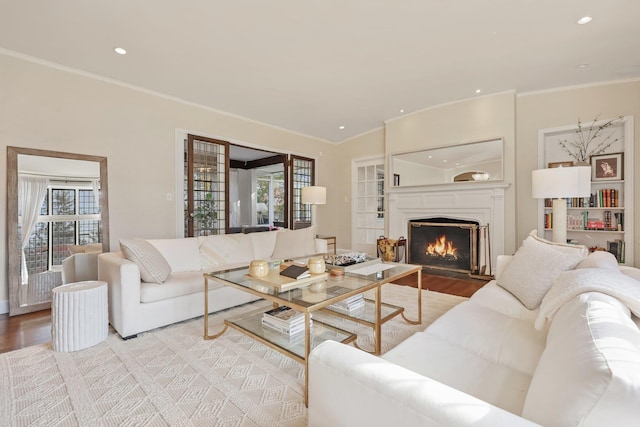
18,182,102,274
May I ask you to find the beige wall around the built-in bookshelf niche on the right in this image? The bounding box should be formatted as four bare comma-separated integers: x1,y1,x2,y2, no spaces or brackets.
516,80,640,265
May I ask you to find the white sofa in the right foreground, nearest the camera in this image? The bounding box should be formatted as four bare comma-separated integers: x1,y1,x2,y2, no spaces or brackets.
308,236,640,427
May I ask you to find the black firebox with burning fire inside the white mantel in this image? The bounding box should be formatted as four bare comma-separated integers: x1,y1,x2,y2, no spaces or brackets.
409,218,480,274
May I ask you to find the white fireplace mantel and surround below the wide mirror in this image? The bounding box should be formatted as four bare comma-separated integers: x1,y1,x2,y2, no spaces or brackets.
385,181,510,273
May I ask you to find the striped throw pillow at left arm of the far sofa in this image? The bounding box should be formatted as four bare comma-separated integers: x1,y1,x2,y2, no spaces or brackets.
120,239,171,283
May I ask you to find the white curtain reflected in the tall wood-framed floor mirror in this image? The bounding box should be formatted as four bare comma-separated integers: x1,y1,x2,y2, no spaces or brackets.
18,176,49,283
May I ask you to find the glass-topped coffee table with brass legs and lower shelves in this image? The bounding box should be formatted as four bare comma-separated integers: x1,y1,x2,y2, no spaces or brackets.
204,261,422,405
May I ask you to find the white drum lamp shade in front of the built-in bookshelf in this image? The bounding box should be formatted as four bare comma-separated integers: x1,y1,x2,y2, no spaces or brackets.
531,166,591,199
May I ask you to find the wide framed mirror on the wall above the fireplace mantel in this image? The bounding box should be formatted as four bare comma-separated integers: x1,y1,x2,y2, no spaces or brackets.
390,138,504,187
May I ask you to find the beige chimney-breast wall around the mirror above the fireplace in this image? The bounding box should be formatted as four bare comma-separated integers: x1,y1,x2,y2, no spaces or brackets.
385,92,516,253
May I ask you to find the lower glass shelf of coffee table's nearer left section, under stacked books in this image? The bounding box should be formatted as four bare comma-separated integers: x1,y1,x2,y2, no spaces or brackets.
224,308,357,365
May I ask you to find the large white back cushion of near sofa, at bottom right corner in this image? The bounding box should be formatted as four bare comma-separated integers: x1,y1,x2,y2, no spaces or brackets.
522,292,640,427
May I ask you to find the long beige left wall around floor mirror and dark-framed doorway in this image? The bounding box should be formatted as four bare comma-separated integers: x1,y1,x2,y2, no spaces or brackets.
0,55,336,305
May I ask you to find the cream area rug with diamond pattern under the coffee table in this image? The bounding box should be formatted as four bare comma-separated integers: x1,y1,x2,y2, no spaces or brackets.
0,284,466,426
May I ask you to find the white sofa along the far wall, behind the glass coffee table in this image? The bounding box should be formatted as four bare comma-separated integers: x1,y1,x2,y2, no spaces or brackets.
98,228,327,338
